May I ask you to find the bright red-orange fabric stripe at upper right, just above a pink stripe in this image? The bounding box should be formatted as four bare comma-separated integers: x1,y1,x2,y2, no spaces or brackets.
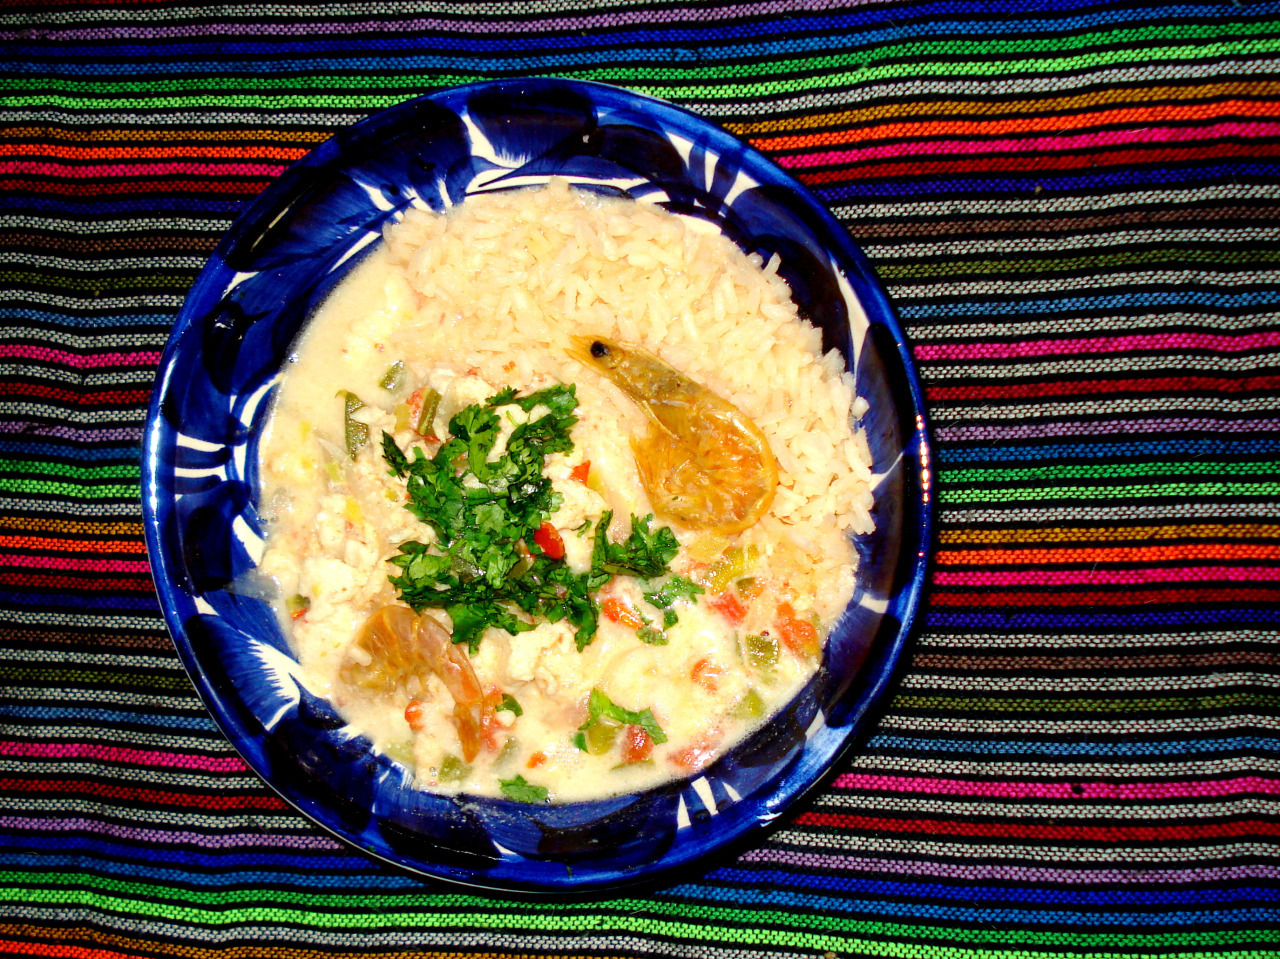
750,100,1275,150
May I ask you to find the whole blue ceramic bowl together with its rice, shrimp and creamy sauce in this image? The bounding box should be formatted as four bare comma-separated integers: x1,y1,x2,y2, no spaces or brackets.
143,81,929,892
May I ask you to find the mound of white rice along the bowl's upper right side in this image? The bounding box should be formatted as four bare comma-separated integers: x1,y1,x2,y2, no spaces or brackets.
385,182,872,545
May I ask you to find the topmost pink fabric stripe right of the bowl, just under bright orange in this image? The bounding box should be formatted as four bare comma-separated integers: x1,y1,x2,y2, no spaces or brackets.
783,120,1280,168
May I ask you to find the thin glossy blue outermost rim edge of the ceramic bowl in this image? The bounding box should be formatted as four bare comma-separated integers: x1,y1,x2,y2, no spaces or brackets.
142,77,934,898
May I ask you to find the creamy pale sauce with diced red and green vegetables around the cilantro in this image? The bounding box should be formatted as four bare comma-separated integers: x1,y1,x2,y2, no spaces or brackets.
260,185,870,802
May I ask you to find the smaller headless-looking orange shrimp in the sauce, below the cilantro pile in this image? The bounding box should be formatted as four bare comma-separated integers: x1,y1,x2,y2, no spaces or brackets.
339,606,485,762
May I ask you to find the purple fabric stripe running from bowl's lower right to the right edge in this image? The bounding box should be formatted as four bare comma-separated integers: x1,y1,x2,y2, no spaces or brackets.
739,848,1280,886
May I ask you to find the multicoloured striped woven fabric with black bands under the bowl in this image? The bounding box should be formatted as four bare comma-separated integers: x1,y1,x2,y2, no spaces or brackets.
0,0,1280,959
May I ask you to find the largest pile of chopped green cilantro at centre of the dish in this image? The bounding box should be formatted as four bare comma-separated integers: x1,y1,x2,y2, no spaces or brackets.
383,384,678,652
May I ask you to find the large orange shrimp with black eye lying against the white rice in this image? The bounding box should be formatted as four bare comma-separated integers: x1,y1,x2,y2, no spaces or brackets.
568,337,778,535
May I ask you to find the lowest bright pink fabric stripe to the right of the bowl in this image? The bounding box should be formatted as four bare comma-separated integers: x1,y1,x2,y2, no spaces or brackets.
833,772,1280,802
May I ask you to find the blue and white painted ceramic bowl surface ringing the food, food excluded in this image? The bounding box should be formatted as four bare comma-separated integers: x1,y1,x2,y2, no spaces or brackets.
142,79,931,894
